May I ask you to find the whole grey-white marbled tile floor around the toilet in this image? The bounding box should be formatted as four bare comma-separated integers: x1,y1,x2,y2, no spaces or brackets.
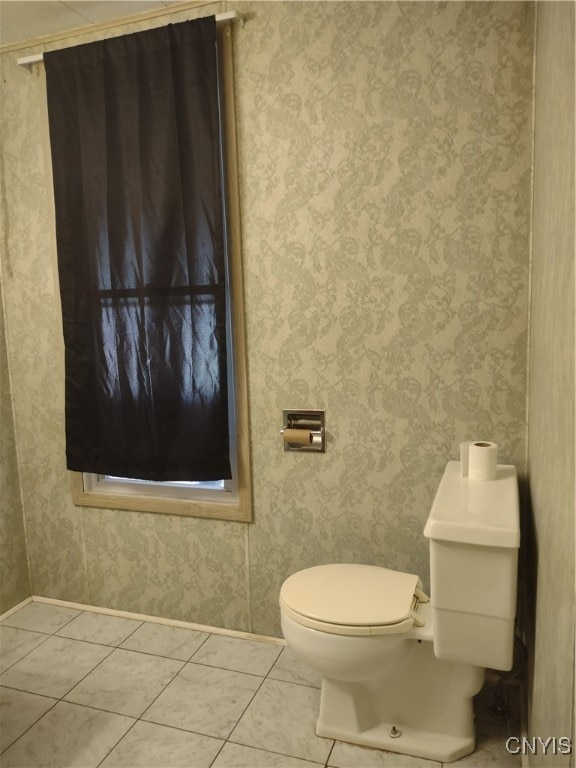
0,602,521,768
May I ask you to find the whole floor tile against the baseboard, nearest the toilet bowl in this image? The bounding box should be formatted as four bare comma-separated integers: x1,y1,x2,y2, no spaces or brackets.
192,635,282,676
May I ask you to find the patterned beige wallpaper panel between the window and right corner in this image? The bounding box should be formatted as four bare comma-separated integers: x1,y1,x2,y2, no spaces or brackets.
236,3,532,632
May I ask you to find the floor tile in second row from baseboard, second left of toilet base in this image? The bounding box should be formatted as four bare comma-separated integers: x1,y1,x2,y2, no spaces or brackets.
142,663,262,739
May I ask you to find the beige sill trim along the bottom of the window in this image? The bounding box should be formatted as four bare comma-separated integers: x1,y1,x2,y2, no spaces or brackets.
71,472,252,523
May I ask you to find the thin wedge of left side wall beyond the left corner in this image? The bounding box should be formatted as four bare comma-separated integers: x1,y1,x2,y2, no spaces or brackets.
0,286,31,615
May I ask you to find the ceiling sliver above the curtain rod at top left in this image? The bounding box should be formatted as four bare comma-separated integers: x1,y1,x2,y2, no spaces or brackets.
0,0,189,46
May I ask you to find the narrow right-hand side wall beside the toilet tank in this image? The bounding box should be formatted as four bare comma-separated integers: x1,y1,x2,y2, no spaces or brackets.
528,3,575,766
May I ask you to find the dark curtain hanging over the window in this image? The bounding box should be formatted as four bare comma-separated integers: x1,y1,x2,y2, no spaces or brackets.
44,17,231,481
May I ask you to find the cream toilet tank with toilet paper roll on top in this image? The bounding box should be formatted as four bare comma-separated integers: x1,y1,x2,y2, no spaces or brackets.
424,461,520,670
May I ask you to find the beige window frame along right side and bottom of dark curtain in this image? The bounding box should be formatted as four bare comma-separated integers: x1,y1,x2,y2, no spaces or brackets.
70,24,252,522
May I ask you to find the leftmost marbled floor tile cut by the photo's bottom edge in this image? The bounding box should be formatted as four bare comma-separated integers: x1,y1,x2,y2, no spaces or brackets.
0,701,134,768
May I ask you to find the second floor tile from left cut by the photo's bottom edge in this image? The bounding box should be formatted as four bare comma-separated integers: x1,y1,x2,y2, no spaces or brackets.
101,720,224,768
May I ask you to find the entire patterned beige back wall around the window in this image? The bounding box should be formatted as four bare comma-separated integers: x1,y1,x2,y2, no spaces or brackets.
2,2,533,634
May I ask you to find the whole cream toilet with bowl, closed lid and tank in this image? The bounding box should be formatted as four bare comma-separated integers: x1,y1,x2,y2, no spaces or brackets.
280,461,520,762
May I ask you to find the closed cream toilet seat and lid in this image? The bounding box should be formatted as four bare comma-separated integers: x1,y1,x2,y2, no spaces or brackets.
280,563,428,635
